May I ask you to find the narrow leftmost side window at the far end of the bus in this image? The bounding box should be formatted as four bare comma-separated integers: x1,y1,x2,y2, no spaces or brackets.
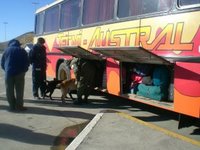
35,13,44,34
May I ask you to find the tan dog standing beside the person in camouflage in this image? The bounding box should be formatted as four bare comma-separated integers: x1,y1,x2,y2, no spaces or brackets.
57,79,77,103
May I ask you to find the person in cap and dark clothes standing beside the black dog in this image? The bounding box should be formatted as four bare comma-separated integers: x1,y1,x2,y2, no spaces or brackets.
29,37,47,99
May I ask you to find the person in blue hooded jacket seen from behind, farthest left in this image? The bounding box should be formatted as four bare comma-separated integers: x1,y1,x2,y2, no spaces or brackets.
1,39,29,111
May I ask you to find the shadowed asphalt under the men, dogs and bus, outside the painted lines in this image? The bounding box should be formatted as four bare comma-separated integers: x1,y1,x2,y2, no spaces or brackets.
0,54,200,150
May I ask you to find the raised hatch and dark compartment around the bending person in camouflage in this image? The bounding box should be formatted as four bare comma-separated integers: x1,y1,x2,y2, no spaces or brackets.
57,46,106,89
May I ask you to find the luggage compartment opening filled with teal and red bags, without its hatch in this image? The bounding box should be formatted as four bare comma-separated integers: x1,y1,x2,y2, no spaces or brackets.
121,62,174,107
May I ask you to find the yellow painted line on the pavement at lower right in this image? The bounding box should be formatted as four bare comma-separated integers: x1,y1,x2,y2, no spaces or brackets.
117,112,200,147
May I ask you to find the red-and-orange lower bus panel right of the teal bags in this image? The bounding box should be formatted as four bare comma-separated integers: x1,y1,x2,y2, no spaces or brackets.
174,62,200,118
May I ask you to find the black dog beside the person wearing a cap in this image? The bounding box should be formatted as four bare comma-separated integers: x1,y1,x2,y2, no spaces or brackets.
43,78,62,100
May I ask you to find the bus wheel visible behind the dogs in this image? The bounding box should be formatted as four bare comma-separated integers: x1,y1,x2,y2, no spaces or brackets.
58,62,71,80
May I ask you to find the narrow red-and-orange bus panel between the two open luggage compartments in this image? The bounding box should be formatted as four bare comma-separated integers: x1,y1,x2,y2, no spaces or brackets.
106,58,120,95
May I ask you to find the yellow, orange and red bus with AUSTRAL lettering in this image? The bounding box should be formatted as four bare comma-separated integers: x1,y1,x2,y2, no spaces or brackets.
35,0,200,127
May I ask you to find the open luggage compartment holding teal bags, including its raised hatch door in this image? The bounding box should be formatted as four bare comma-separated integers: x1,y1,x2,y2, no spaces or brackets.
92,47,174,109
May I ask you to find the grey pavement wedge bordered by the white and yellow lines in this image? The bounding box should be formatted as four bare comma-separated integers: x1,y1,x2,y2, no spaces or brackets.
65,111,200,150
